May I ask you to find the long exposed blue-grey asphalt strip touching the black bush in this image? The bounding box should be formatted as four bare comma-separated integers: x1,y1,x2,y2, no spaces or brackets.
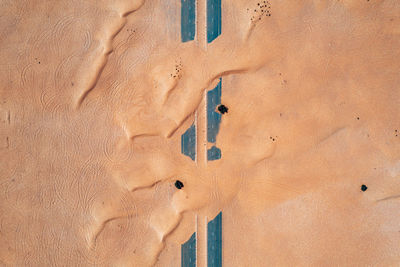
207,79,222,143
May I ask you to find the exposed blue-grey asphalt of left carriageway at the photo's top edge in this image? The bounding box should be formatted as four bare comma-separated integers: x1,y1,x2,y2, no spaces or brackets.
181,0,196,42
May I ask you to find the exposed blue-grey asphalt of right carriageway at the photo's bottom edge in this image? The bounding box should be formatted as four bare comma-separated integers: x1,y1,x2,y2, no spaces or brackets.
207,212,222,267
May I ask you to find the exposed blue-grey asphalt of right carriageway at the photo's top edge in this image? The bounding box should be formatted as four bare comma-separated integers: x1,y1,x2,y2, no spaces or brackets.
207,0,221,43
